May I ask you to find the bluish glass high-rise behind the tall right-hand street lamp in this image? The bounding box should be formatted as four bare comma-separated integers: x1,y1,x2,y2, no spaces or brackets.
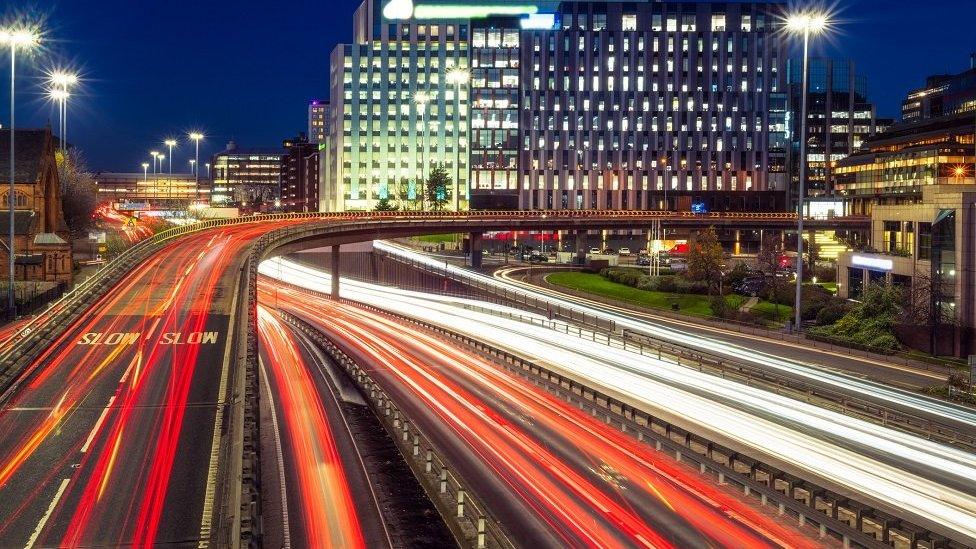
787,57,891,196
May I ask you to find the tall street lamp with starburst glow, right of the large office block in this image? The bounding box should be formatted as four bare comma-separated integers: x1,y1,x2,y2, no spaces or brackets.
786,12,828,332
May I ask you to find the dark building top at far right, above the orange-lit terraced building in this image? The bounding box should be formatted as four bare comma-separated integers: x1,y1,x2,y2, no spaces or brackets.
901,53,976,122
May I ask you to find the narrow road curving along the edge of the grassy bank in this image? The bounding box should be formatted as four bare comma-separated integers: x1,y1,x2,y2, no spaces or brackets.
493,267,946,389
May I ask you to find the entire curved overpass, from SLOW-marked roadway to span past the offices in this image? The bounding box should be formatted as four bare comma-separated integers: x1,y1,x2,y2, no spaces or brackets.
0,210,869,546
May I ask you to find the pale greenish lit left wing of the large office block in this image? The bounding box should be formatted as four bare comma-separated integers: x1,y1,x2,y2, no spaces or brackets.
321,0,468,211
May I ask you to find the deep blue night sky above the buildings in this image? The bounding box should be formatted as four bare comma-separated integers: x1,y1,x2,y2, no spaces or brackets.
0,0,976,171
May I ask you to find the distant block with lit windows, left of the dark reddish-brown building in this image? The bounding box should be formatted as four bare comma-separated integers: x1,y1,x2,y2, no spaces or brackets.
210,141,285,207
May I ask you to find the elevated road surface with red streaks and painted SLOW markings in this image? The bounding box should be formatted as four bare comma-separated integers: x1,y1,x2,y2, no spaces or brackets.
0,220,304,546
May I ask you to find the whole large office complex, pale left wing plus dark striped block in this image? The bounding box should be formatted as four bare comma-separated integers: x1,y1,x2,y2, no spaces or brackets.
326,0,788,210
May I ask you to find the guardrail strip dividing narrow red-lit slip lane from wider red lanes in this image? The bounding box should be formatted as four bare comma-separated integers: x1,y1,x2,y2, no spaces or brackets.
278,311,515,549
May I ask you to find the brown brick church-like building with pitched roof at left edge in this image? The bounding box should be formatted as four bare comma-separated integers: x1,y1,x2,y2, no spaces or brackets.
0,128,73,284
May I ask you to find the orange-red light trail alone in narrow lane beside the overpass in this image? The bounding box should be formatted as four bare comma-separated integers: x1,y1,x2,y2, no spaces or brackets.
258,306,366,548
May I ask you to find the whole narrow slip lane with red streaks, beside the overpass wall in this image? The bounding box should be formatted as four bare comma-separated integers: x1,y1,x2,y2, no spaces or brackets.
258,305,392,548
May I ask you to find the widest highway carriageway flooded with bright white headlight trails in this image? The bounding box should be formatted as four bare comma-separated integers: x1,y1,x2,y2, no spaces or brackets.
261,261,976,540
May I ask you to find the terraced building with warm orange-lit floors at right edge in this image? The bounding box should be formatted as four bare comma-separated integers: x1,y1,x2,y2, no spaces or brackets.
833,113,976,214
